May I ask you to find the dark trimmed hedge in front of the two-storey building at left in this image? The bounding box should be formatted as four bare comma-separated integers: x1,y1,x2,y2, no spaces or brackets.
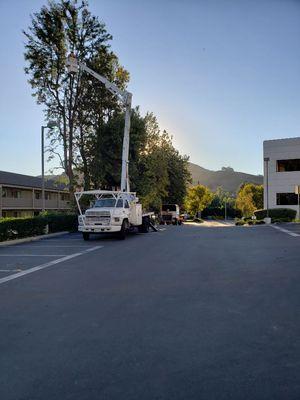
0,214,77,242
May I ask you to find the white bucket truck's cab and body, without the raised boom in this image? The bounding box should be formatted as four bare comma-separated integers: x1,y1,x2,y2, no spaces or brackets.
75,190,153,240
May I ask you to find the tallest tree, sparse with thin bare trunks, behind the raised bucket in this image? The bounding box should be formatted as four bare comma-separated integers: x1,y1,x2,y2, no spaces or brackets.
24,0,129,192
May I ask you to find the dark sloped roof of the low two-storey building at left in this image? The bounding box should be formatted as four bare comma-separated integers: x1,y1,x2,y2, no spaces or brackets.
0,171,68,191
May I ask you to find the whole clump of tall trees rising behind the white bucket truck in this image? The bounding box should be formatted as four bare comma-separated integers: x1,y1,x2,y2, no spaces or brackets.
24,0,189,210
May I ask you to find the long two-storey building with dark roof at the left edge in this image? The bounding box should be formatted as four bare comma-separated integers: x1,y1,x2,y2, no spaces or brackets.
0,171,70,218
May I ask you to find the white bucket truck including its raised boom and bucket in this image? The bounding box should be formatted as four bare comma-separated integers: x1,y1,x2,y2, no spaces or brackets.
67,53,157,240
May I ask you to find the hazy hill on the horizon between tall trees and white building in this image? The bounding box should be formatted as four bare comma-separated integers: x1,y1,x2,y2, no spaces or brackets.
189,162,263,193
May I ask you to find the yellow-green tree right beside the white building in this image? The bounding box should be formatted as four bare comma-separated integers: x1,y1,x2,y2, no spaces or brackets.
236,183,264,217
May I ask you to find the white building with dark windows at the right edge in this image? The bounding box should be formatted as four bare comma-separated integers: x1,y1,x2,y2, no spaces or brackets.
264,137,300,218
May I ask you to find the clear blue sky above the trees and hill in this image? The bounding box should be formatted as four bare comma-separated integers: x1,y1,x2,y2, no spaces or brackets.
0,0,300,175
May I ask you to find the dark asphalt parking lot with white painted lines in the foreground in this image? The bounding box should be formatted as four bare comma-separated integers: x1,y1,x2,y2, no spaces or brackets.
0,225,300,400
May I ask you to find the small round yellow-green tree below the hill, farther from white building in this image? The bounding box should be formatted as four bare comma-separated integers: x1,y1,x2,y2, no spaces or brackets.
185,185,213,216
